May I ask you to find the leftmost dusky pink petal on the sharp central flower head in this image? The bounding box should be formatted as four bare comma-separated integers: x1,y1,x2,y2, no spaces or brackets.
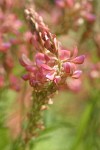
19,54,32,66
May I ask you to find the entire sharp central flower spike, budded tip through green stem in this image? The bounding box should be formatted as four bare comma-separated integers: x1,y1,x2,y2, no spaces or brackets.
20,8,85,148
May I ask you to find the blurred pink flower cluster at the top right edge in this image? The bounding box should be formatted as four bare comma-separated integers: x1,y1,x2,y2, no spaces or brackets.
55,0,96,26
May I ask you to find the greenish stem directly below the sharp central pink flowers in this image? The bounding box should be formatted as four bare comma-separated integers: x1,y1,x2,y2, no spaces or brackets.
25,85,55,143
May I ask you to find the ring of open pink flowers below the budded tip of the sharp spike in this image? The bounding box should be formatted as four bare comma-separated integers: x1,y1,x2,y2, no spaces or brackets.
20,49,85,87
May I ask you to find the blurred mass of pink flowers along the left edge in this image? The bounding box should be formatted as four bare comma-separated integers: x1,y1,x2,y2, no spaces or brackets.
0,0,31,91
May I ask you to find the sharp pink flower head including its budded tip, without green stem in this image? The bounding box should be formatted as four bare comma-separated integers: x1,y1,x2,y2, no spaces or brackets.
20,9,85,90
